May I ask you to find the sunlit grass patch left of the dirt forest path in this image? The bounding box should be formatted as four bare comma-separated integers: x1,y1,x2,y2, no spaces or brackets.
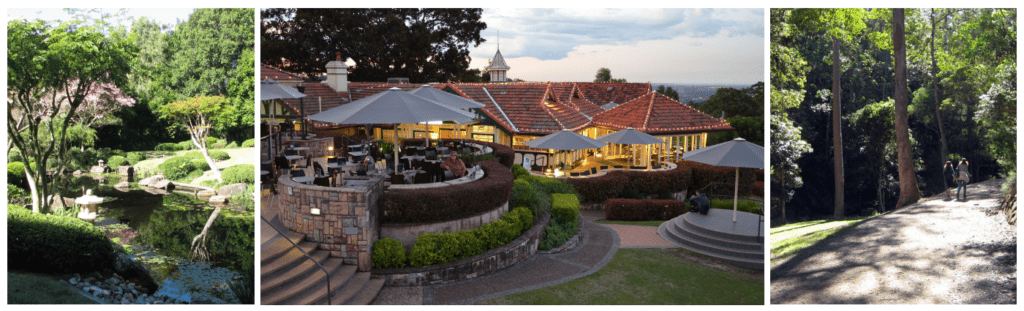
769,217,869,260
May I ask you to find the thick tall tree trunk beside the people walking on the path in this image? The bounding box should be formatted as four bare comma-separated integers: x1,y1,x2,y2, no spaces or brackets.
893,8,921,209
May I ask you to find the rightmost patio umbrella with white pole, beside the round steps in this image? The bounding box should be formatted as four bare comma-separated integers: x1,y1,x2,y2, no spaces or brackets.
683,137,765,222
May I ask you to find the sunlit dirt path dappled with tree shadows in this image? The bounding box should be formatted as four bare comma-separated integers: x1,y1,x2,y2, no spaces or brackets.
771,179,1017,304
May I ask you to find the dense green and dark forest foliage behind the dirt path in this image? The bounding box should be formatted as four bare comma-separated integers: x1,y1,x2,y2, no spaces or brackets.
770,8,1017,220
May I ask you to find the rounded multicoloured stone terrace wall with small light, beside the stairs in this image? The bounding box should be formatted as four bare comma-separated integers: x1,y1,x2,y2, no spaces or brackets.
278,176,384,271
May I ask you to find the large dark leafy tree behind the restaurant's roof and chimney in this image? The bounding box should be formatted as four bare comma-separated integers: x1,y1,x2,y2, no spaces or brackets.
260,8,487,82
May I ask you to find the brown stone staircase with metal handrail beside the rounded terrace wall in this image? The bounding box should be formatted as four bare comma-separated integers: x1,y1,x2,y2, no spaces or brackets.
260,231,384,305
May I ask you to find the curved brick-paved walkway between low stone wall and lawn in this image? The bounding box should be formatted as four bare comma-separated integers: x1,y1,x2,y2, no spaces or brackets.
373,207,618,305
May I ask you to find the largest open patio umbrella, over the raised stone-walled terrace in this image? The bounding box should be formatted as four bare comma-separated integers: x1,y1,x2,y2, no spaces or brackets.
307,88,475,169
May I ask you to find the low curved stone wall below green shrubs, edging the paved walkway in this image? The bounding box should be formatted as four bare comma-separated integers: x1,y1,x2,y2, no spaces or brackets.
373,215,551,286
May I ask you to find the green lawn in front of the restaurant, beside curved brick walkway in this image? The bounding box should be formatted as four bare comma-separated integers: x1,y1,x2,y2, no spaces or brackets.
485,249,765,305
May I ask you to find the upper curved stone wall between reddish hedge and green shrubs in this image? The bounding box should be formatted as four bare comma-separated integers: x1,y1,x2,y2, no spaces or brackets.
380,203,509,251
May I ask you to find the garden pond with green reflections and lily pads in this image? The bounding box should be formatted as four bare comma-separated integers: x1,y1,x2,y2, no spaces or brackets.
60,175,255,302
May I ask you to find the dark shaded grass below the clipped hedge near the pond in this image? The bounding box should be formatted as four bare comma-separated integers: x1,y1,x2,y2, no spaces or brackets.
7,271,97,305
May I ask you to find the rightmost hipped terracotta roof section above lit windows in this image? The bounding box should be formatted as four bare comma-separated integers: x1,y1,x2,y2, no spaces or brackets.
593,92,733,134
